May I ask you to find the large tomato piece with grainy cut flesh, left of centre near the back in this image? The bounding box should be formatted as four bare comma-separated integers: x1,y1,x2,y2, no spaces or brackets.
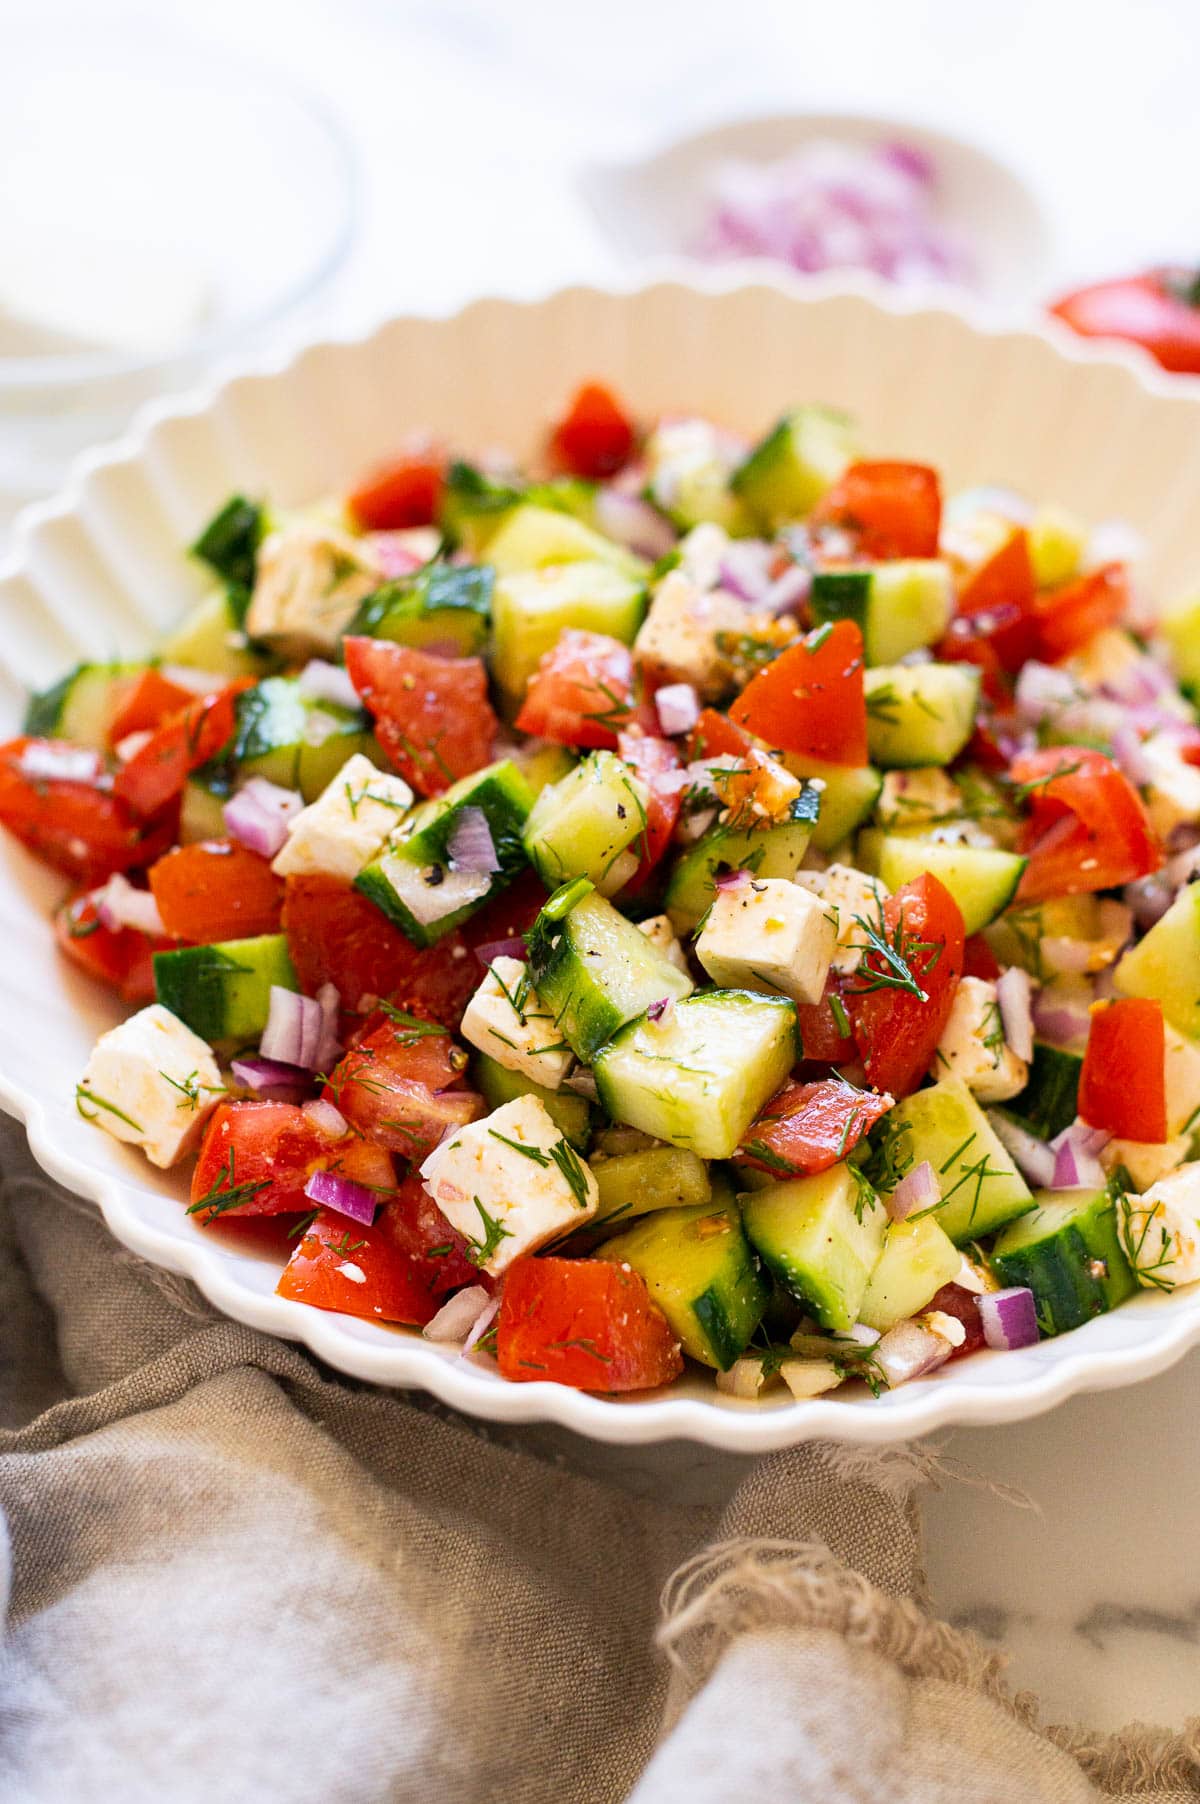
343,639,498,796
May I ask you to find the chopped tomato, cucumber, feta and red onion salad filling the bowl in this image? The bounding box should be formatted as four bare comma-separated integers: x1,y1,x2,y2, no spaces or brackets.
14,384,1200,1398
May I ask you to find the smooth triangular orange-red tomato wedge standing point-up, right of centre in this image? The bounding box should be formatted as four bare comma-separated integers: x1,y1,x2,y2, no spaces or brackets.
729,621,866,765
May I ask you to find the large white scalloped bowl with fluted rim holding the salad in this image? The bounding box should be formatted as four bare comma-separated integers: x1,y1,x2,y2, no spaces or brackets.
0,272,1200,1452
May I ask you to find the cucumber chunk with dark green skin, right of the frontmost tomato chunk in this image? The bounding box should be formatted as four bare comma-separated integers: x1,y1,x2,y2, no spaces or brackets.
595,1196,769,1371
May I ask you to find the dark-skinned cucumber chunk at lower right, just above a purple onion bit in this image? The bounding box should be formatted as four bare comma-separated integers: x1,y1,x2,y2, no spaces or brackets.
991,1187,1137,1335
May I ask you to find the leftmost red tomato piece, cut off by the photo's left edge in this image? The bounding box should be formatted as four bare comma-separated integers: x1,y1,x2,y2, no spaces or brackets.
0,738,175,888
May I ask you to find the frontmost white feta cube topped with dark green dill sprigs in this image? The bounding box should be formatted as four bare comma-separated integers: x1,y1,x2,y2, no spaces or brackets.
420,1097,599,1277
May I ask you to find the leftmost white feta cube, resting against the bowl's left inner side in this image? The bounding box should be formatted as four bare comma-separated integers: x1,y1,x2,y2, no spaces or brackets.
76,1003,226,1167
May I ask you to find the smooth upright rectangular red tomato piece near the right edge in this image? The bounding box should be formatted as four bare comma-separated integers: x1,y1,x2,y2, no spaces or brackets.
1079,996,1168,1146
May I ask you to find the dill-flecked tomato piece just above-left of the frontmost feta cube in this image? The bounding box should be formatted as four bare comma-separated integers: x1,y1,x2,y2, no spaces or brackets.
323,1016,484,1160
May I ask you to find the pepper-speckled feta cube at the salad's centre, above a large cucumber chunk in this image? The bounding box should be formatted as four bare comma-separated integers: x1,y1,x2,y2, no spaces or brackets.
697,875,837,1003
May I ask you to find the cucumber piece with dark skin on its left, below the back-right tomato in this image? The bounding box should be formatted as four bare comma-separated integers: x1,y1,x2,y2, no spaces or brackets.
808,557,955,664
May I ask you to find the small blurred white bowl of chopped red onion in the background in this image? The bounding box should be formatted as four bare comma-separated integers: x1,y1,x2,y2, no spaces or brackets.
581,114,1050,303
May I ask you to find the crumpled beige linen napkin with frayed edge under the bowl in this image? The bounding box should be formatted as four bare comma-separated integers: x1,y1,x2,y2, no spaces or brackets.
0,1124,1200,1804
